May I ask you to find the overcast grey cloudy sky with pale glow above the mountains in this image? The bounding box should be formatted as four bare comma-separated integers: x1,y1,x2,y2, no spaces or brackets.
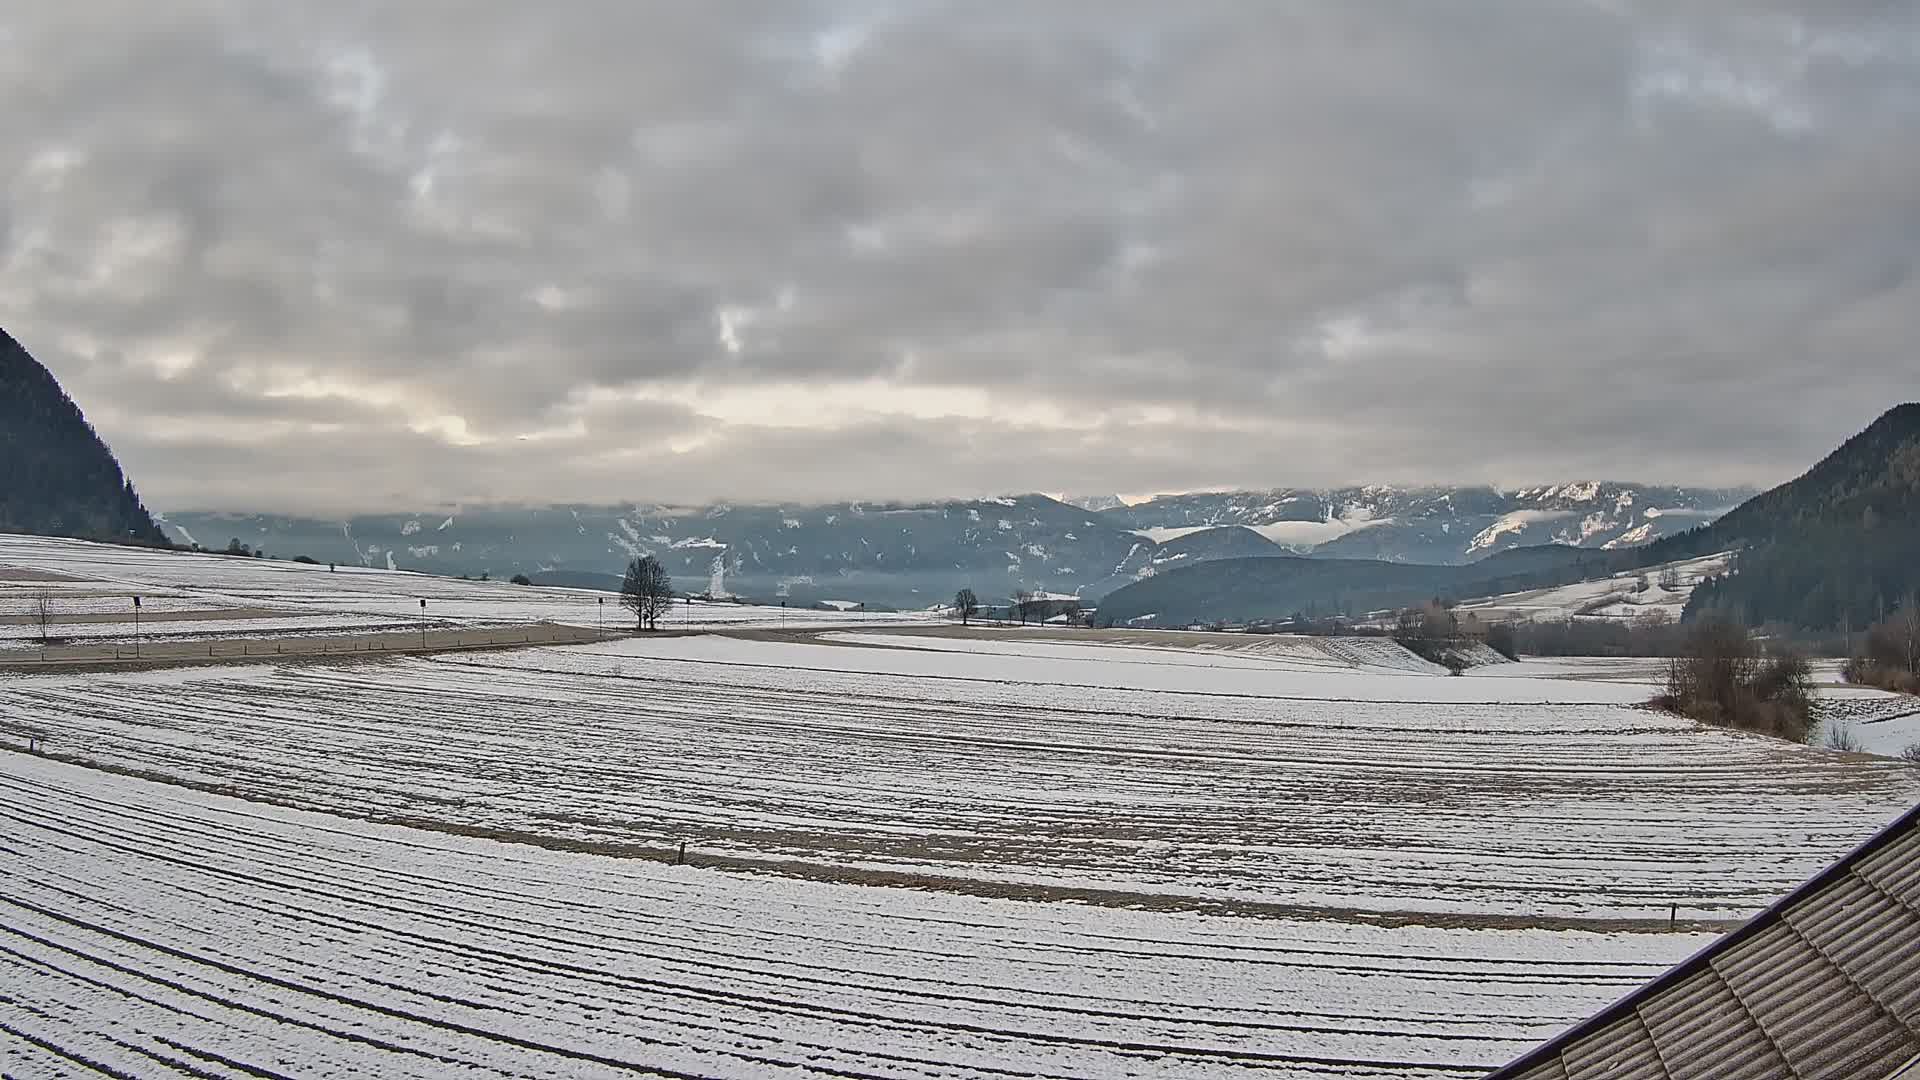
0,0,1920,511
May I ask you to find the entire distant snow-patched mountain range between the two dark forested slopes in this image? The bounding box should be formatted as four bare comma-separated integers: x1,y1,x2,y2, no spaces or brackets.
163,482,1749,607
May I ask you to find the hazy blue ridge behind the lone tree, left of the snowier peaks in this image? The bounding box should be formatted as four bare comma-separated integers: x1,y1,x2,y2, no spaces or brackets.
163,496,1156,607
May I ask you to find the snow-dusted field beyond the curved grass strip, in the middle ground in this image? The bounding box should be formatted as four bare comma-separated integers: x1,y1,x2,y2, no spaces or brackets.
0,636,1920,919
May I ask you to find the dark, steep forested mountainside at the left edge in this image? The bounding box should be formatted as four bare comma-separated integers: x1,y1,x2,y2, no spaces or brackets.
0,331,165,544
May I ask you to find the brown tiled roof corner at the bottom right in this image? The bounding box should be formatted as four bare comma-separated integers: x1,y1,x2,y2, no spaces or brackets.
1488,807,1920,1080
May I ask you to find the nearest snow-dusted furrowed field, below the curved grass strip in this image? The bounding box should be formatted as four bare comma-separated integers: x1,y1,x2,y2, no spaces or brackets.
0,751,1707,1078
